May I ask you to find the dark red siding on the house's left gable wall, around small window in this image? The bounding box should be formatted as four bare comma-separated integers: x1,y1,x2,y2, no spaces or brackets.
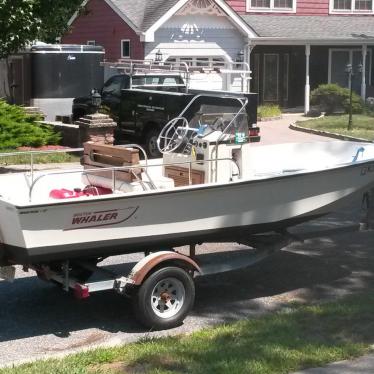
62,0,144,61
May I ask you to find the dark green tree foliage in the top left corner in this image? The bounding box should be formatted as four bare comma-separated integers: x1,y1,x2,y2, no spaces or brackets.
0,0,82,58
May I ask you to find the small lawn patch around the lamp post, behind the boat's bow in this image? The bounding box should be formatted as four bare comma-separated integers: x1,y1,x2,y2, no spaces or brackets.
297,114,374,141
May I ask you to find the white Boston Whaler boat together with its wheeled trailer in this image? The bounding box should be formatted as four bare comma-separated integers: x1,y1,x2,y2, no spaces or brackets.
0,96,374,329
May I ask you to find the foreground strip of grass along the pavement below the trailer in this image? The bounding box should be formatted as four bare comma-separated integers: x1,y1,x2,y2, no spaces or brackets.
0,291,374,374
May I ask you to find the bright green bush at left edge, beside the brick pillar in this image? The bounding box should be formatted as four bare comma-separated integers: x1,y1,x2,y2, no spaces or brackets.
0,100,61,149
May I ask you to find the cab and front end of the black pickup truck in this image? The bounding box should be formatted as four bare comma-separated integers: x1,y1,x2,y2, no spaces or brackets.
72,73,186,122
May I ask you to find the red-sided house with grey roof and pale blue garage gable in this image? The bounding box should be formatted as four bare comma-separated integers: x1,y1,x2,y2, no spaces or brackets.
62,0,374,112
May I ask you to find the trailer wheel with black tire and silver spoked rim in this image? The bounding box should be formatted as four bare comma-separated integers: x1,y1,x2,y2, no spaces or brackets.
133,266,195,330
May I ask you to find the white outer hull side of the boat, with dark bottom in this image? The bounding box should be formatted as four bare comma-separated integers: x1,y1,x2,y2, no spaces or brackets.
0,142,374,264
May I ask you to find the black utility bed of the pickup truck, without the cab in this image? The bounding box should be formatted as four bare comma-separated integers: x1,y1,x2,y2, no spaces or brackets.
115,89,260,157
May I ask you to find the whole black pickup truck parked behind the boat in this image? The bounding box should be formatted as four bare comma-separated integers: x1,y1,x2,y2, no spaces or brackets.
72,73,260,157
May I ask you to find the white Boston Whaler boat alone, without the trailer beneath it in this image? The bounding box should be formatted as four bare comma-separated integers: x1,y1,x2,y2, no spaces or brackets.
0,96,374,264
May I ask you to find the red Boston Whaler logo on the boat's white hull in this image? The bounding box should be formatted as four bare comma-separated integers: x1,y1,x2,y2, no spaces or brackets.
64,206,139,231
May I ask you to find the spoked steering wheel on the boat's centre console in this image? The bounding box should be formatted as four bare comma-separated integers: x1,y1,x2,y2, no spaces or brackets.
157,117,190,153
